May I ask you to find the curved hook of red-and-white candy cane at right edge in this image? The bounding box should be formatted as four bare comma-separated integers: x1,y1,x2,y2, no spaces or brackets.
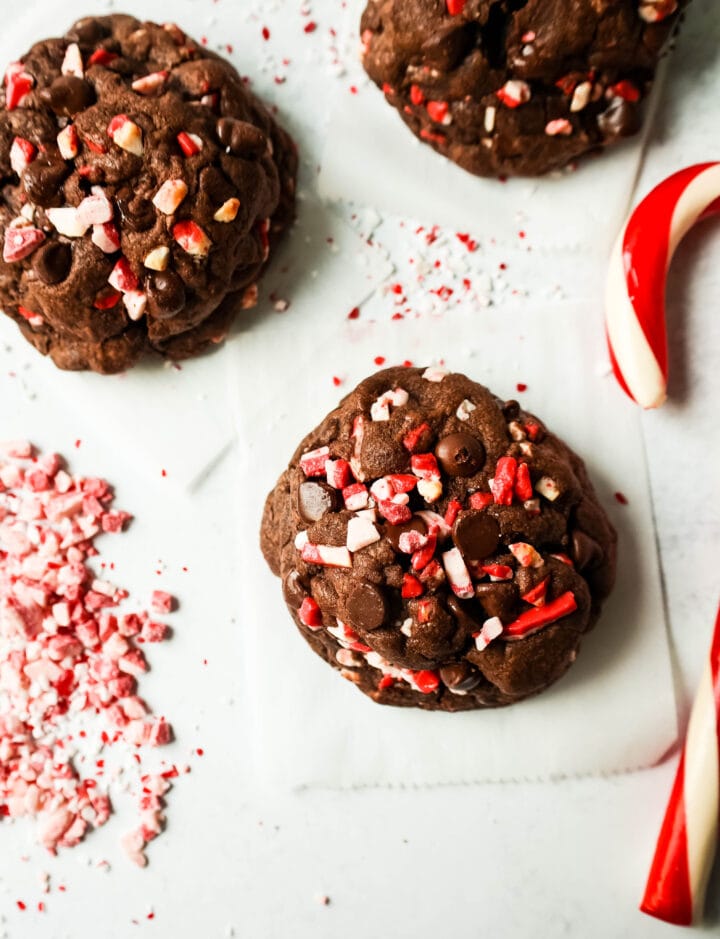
605,163,720,408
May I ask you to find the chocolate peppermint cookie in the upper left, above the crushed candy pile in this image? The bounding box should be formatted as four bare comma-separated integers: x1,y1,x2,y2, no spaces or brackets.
0,15,297,373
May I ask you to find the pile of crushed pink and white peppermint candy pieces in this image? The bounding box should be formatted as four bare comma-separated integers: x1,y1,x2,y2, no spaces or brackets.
0,442,178,866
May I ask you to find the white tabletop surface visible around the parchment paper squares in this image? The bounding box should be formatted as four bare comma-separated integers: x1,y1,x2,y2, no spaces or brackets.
0,0,720,939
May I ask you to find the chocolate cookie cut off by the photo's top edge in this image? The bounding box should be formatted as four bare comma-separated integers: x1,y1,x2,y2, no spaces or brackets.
361,0,684,176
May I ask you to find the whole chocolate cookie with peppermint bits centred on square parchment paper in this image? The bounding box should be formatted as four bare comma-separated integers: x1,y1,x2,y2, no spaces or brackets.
261,368,616,711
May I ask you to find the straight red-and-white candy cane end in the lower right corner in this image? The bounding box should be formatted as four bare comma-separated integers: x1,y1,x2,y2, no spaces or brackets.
640,609,720,926
